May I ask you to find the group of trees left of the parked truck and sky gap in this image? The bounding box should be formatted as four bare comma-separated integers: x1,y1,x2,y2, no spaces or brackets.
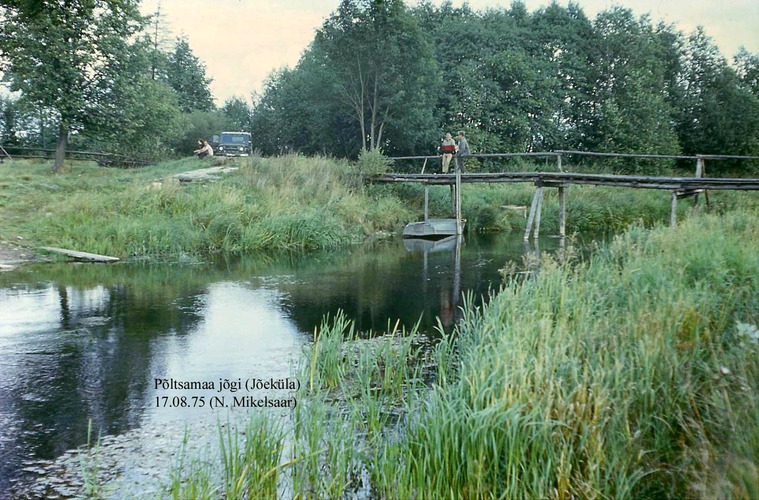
0,0,242,170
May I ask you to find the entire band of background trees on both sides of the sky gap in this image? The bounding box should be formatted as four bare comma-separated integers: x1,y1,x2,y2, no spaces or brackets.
0,0,759,175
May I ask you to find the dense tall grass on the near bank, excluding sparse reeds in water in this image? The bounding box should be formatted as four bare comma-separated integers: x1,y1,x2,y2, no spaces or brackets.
372,209,759,498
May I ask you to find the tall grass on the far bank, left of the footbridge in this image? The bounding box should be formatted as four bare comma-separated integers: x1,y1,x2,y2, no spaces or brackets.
0,155,410,259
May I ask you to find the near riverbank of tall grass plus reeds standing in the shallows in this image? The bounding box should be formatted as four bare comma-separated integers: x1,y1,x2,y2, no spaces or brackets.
162,212,759,499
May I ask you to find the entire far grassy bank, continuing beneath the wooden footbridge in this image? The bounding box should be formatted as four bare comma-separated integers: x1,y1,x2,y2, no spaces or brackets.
0,155,759,260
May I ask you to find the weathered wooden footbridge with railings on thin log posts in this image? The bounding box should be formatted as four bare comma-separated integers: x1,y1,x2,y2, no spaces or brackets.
370,151,759,240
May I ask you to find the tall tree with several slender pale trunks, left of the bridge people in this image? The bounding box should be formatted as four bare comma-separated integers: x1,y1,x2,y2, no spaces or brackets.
311,0,437,150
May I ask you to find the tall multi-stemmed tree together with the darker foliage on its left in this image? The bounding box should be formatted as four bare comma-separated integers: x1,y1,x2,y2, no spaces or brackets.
253,0,438,157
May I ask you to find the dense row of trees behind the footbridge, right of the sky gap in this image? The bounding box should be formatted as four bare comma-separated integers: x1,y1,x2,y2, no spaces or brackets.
251,0,759,173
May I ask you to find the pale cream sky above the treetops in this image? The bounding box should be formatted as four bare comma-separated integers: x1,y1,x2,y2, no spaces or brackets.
142,0,759,105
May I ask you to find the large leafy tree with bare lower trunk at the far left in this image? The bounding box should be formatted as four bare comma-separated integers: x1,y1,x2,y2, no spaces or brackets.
0,0,143,172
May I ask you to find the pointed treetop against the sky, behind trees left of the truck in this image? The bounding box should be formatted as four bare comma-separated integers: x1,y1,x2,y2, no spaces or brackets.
166,38,216,113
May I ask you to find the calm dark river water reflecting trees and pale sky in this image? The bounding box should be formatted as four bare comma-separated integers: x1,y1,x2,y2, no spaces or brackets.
0,235,559,498
